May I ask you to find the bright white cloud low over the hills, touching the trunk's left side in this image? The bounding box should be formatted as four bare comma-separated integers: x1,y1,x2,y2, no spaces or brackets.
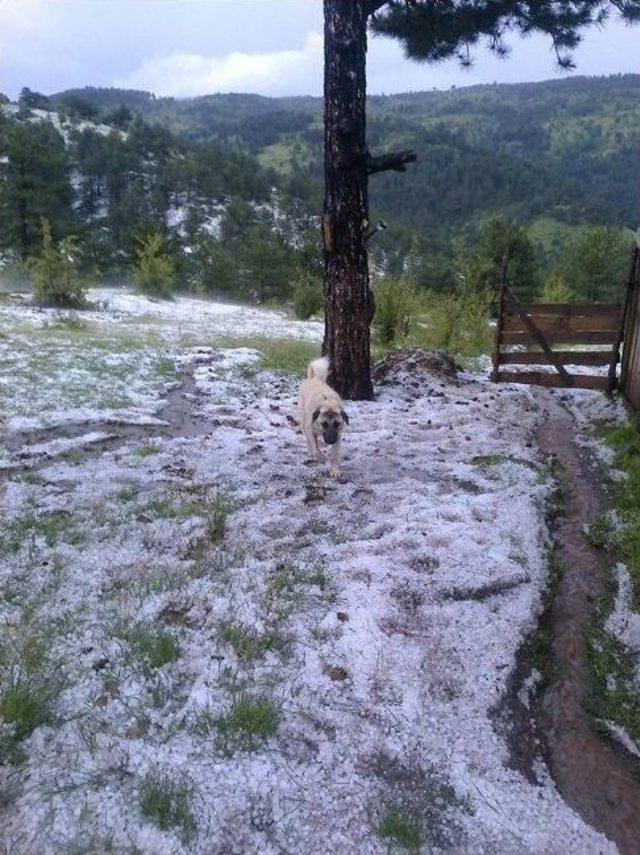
115,33,323,97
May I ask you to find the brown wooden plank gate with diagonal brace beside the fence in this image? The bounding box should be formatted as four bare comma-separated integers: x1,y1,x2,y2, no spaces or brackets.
491,247,640,398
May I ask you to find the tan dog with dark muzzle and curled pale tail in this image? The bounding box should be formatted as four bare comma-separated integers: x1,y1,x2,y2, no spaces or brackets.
298,356,349,478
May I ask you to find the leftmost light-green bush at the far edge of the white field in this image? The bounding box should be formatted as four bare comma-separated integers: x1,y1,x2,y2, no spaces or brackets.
26,219,87,309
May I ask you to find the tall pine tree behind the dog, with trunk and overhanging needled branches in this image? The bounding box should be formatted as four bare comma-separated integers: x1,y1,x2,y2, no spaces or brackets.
323,0,640,398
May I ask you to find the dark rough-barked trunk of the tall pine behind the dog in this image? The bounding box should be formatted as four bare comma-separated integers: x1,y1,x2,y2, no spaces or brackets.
322,0,374,400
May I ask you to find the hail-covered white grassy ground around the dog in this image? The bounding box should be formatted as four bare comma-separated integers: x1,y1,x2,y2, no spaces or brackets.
0,292,615,855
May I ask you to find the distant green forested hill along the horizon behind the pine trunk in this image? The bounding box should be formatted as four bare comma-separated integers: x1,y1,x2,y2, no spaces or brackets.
52,72,640,234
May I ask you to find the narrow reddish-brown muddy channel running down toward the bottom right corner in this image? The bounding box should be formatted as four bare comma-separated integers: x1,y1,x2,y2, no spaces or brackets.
538,400,640,855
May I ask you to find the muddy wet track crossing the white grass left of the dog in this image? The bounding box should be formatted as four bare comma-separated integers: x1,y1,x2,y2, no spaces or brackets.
0,358,212,481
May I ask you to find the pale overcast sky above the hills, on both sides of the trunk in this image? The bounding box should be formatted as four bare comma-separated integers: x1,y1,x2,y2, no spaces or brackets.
0,0,640,97
